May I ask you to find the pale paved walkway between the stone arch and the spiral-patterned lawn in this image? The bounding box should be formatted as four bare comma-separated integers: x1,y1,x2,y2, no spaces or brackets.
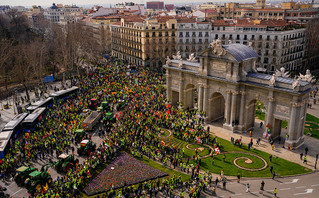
206,123,319,169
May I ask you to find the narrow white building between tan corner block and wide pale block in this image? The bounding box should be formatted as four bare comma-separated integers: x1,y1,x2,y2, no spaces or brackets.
176,17,212,58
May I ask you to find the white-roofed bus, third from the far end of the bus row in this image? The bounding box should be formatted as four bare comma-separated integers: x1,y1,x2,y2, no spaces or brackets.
22,107,45,132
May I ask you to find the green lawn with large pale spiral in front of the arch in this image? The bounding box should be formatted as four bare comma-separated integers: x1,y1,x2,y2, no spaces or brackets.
202,137,311,177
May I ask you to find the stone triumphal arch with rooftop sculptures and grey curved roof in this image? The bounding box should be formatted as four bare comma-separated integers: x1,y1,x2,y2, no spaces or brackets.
164,40,311,148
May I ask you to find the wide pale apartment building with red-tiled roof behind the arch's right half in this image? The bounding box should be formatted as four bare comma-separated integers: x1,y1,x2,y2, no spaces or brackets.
211,19,305,73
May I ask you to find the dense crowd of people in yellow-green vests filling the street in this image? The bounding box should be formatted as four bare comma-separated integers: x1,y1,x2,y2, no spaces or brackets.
0,58,225,197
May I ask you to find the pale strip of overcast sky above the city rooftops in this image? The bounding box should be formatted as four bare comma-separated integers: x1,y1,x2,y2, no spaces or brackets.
0,0,258,7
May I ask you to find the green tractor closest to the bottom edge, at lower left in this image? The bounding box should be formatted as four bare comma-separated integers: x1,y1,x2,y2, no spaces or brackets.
24,163,54,194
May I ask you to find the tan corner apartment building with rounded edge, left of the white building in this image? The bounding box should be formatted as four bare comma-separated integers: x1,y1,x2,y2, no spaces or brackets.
111,16,177,66
